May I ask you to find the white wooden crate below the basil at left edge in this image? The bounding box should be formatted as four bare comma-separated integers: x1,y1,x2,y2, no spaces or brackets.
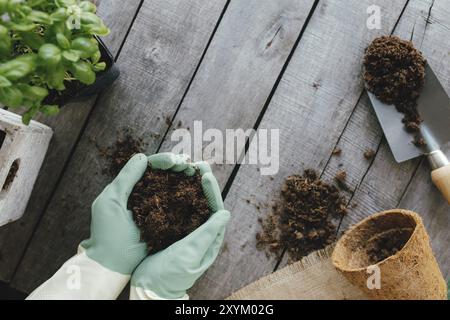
0,109,53,226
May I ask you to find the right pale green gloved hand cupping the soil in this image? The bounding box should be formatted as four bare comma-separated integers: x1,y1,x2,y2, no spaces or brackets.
130,154,230,299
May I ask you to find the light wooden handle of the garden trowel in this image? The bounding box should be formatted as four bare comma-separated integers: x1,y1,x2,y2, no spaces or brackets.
428,151,450,204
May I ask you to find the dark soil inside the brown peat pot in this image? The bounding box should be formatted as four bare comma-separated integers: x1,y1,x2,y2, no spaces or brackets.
366,229,412,264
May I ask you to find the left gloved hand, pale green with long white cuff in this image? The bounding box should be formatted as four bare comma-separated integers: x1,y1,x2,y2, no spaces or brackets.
28,154,148,300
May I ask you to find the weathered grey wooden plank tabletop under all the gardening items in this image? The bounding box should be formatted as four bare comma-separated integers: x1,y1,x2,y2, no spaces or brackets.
0,0,450,299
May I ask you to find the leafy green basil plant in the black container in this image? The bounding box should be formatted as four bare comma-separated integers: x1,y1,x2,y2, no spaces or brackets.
0,0,109,124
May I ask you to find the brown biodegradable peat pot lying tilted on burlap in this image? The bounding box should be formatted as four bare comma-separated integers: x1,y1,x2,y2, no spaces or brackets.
332,209,447,300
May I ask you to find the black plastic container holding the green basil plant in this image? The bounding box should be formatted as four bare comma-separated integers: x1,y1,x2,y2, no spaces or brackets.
44,37,120,107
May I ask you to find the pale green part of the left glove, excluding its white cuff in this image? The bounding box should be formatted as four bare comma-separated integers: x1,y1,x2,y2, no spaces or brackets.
80,154,148,275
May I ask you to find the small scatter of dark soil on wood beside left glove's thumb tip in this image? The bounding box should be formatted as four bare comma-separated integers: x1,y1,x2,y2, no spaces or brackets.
99,130,145,177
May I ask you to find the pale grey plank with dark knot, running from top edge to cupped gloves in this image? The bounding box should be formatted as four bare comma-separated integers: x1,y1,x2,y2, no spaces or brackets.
161,0,314,187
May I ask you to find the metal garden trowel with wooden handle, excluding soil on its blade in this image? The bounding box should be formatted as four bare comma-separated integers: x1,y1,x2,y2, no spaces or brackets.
368,66,450,203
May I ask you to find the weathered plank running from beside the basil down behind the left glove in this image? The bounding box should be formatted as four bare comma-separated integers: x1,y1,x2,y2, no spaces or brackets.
12,0,226,292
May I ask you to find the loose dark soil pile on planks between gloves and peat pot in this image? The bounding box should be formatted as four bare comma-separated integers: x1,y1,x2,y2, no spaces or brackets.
256,170,347,261
